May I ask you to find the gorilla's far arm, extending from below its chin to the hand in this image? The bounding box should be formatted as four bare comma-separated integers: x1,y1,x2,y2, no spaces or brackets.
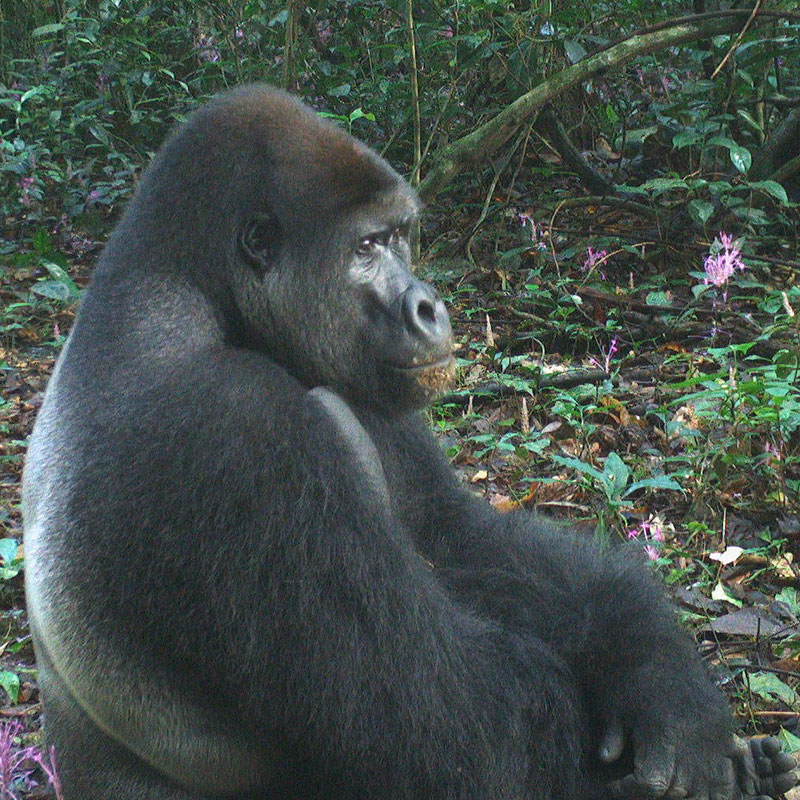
368,418,793,800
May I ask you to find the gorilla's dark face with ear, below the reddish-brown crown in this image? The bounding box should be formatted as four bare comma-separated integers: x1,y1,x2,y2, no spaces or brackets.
235,179,454,414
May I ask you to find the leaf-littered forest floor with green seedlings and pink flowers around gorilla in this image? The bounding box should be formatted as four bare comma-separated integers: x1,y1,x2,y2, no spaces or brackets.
0,186,800,798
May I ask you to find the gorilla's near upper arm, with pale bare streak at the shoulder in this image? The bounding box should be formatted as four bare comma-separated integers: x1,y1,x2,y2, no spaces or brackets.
241,388,592,798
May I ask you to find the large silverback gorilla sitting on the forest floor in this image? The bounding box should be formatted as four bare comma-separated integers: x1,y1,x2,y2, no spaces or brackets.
24,86,794,800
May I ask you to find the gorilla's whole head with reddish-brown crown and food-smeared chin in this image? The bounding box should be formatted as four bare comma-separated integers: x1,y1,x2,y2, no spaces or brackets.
110,86,453,415
